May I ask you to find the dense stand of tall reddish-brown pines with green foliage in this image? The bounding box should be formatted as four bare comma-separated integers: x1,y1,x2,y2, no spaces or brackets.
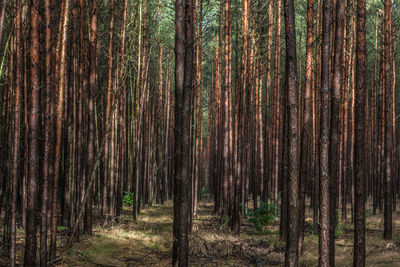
0,0,400,266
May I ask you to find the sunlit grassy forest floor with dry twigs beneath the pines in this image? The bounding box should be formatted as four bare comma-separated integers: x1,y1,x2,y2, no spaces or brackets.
59,201,400,267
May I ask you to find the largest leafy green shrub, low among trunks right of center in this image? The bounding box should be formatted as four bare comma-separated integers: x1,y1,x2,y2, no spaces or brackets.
248,201,279,233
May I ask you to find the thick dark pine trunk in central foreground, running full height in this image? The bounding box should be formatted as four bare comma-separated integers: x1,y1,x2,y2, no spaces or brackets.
172,0,194,267
